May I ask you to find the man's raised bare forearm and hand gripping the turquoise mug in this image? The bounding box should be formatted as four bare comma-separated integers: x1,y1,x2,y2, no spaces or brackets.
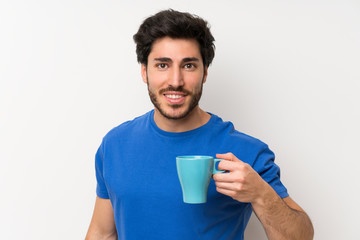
214,153,314,240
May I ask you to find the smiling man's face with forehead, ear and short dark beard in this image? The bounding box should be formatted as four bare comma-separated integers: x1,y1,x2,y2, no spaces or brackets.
141,37,207,119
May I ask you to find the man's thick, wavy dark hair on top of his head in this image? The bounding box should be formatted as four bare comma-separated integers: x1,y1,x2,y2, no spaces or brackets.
133,9,215,66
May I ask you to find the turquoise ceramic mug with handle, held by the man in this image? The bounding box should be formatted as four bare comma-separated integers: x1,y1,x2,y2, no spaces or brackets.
176,156,225,203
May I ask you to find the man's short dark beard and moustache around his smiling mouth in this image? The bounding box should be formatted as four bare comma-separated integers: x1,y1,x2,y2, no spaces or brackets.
147,80,203,120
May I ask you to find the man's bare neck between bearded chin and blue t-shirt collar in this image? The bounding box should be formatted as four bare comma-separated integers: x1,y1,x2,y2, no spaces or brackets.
154,107,211,132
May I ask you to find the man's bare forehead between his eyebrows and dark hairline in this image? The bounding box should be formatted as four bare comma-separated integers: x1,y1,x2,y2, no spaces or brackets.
149,37,202,61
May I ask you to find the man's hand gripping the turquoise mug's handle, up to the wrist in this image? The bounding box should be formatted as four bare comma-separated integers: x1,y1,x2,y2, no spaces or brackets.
213,153,271,203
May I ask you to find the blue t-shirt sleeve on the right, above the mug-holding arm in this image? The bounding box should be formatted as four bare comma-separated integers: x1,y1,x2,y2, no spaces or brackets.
253,146,289,198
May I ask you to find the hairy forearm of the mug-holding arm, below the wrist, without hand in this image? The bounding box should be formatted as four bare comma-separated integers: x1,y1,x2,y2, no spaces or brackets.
252,186,314,240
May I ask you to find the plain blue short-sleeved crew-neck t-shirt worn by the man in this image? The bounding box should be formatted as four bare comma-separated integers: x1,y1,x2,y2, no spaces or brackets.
96,110,288,240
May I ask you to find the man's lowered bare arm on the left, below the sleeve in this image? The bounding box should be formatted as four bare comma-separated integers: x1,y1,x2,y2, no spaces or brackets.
85,197,117,240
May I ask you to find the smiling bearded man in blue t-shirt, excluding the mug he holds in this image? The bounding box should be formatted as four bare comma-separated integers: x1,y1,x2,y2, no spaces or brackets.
86,10,313,240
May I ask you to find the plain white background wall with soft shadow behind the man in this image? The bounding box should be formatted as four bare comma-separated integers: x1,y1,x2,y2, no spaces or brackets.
0,0,360,240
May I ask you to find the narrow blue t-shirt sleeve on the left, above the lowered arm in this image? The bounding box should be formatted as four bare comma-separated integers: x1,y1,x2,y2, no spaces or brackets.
95,143,109,199
